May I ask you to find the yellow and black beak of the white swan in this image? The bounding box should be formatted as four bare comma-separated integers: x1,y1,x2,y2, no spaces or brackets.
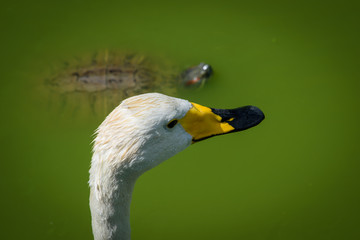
179,103,265,143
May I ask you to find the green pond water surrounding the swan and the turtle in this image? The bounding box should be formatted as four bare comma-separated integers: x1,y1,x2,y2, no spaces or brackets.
0,0,360,240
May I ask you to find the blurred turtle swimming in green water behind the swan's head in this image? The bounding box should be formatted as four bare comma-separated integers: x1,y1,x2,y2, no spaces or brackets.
44,50,212,117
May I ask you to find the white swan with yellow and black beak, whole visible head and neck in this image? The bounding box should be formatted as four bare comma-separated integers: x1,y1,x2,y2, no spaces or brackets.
89,93,264,240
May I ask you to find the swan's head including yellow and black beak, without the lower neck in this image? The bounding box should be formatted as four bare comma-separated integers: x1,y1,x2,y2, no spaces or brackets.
90,93,264,182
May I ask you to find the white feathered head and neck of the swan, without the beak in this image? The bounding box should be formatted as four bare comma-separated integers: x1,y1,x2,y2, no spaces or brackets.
89,93,192,240
